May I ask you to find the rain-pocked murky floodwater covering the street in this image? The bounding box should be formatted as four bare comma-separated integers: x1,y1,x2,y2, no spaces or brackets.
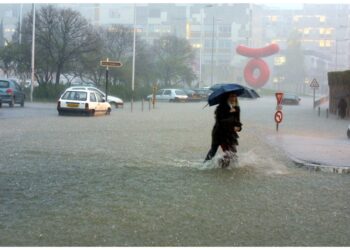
0,98,350,246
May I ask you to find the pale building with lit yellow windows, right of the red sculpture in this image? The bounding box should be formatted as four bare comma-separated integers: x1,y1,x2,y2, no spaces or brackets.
264,4,350,94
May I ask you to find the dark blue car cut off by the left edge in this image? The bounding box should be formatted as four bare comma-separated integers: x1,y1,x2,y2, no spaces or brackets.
0,79,26,107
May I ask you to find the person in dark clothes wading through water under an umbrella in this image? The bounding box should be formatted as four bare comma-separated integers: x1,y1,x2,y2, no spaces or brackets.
204,93,243,168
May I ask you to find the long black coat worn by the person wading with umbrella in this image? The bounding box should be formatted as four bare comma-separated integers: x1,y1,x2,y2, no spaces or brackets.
212,103,243,145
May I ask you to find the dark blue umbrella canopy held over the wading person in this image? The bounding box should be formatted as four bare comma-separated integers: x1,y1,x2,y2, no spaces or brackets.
208,83,246,106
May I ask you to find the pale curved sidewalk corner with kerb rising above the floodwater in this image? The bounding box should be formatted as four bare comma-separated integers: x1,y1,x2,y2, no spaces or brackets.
267,134,350,173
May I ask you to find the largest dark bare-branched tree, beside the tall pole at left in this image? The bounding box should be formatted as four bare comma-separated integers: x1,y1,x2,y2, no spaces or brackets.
22,5,97,84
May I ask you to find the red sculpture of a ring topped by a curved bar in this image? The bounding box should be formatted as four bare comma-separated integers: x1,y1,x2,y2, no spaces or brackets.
236,44,279,88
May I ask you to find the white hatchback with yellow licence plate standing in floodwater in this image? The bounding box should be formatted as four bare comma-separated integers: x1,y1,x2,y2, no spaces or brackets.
57,89,111,116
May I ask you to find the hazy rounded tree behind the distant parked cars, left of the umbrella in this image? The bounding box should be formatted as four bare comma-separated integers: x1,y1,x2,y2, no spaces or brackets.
152,35,195,86
